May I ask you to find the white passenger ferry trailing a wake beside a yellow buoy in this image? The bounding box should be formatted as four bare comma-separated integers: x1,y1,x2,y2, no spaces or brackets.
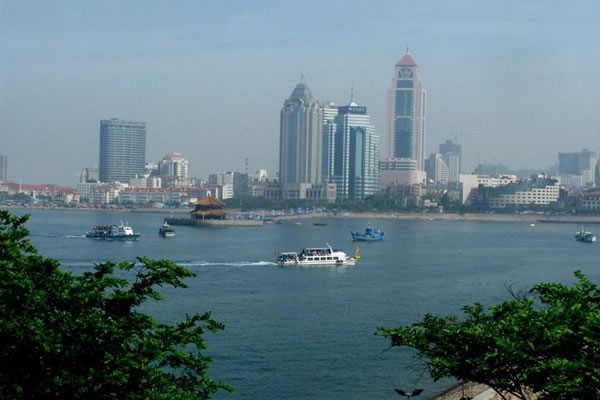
276,244,360,266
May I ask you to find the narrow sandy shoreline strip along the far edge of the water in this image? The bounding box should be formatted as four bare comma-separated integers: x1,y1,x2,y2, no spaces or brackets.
5,207,600,224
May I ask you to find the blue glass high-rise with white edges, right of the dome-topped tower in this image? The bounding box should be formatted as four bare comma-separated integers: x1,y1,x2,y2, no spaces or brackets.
323,103,379,199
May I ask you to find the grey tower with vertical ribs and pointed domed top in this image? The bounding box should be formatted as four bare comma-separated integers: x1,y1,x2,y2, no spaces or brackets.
279,80,323,190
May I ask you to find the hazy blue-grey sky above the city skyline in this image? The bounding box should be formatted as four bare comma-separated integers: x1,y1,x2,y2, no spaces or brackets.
0,0,600,185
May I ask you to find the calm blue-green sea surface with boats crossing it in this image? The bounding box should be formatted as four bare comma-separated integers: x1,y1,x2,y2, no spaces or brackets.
16,210,600,399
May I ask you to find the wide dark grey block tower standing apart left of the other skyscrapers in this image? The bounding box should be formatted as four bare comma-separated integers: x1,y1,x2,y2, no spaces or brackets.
99,118,146,182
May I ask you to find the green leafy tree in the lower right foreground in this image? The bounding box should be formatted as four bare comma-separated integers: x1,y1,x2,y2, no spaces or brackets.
376,271,600,400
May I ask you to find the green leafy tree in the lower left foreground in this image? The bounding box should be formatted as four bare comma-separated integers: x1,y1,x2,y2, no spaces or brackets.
0,211,232,400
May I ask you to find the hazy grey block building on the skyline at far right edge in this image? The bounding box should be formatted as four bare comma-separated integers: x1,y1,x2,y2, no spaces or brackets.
558,149,598,186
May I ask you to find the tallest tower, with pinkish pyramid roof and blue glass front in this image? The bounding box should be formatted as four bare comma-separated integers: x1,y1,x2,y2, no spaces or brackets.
387,50,425,170
